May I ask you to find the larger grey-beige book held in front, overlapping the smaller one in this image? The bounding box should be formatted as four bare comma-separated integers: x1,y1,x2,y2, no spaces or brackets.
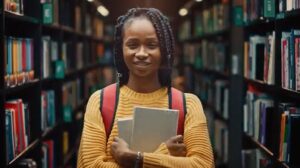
131,107,179,152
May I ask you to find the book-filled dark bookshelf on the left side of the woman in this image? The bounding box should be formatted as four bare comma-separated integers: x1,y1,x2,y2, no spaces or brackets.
0,0,115,167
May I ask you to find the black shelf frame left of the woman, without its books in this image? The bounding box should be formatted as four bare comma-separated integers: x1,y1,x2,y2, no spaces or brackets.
0,0,113,168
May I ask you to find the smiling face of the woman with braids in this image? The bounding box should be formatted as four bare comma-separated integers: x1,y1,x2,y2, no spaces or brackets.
123,18,161,77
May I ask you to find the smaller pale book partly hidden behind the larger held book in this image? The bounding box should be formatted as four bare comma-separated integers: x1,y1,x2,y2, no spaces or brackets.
117,117,133,147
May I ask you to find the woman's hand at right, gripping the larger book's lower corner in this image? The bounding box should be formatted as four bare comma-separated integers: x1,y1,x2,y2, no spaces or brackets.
166,135,186,156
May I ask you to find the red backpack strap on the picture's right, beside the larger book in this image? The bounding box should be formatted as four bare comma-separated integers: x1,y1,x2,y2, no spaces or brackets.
168,87,186,135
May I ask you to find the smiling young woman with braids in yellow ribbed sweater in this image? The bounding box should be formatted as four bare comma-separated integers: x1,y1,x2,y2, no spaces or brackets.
77,8,214,168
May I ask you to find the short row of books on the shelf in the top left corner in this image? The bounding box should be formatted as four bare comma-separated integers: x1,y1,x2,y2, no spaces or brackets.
4,0,24,15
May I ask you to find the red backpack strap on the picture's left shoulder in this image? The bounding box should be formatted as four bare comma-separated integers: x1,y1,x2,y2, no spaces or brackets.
100,83,119,140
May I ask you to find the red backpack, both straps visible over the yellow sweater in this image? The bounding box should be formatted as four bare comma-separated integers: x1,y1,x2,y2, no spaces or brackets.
100,83,186,138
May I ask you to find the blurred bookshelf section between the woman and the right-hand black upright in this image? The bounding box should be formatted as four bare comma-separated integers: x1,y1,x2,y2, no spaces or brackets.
178,0,231,168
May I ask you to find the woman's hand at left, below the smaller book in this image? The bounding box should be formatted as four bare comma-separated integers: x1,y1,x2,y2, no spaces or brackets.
111,137,135,167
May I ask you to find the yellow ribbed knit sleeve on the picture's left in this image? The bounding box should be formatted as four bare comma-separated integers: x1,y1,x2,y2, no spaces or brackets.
77,91,119,168
